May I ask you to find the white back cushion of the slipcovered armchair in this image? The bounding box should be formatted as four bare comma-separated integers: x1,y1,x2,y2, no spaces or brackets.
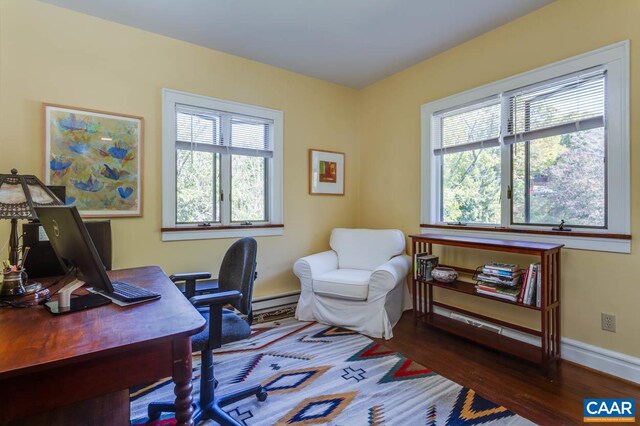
329,228,405,271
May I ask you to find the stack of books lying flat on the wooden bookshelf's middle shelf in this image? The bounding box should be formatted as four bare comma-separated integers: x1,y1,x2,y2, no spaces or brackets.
475,263,522,302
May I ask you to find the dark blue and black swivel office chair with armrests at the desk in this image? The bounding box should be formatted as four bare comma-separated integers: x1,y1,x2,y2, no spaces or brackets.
148,238,267,426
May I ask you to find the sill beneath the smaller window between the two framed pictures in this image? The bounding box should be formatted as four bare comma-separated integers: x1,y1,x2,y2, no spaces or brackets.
161,225,284,241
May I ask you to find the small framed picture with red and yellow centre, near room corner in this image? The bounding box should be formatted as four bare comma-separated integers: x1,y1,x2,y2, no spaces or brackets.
309,149,344,195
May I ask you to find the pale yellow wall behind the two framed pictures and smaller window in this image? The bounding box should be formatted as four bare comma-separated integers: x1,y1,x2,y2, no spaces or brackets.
0,0,359,296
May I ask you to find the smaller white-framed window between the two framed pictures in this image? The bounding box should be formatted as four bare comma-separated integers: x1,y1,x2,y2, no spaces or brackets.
163,89,282,240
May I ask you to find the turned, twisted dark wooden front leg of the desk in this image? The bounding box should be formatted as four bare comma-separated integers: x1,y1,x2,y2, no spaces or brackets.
173,337,193,426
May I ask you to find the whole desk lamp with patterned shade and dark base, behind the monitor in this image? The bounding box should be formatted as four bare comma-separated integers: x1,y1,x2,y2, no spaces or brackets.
0,169,64,297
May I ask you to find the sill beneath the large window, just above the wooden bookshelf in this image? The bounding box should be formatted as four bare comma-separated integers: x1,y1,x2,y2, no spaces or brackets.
420,224,631,253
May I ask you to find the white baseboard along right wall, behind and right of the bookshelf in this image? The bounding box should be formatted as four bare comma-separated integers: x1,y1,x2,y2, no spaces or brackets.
434,306,640,384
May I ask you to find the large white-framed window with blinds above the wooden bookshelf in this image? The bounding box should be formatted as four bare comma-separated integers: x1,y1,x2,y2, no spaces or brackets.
422,43,630,251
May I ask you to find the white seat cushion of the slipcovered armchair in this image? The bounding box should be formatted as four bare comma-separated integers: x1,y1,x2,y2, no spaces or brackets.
313,269,371,300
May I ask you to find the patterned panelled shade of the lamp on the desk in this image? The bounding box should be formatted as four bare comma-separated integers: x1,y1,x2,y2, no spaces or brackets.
0,169,64,219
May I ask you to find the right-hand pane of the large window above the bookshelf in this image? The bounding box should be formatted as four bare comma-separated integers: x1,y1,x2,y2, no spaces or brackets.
503,67,608,229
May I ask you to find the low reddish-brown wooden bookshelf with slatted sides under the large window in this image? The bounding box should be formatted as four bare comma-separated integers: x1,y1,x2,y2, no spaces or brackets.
411,234,563,366
